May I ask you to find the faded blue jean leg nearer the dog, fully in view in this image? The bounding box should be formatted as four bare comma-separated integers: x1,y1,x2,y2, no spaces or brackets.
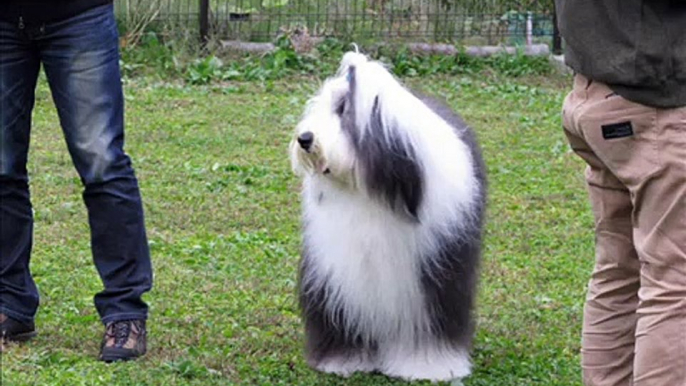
41,5,152,323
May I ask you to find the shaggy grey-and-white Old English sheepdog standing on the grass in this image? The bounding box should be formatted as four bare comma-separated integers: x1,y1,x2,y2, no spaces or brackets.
289,52,486,381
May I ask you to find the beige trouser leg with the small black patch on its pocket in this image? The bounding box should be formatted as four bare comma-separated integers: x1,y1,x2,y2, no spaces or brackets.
575,78,686,386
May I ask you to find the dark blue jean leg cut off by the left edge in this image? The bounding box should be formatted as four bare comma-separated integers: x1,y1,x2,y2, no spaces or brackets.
0,21,40,323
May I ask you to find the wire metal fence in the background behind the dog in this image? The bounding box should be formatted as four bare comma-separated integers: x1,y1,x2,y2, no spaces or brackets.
115,0,556,44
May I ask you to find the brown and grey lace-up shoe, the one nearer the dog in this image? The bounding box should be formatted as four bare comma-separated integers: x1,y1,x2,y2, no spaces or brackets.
100,320,147,363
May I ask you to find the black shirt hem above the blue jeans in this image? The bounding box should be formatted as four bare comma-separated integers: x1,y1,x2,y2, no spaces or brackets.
0,0,113,24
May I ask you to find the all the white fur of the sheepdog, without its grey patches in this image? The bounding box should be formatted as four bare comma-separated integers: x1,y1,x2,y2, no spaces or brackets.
290,53,480,380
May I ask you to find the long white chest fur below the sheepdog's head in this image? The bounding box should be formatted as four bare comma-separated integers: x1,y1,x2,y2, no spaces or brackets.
304,178,428,340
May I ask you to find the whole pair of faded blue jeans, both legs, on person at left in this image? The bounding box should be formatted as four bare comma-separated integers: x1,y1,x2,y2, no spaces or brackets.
0,4,152,323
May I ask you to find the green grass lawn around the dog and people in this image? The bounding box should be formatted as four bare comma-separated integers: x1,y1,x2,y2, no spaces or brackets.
1,65,593,386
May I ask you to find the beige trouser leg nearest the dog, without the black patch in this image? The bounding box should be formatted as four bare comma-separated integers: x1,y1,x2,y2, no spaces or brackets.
563,77,639,386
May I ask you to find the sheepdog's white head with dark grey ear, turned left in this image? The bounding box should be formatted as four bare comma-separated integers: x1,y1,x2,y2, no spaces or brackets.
290,52,422,216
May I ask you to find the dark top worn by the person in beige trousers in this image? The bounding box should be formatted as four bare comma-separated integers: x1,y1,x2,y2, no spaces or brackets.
555,0,686,108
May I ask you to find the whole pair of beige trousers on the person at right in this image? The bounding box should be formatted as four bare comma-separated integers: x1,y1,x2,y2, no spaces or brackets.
562,75,686,386
